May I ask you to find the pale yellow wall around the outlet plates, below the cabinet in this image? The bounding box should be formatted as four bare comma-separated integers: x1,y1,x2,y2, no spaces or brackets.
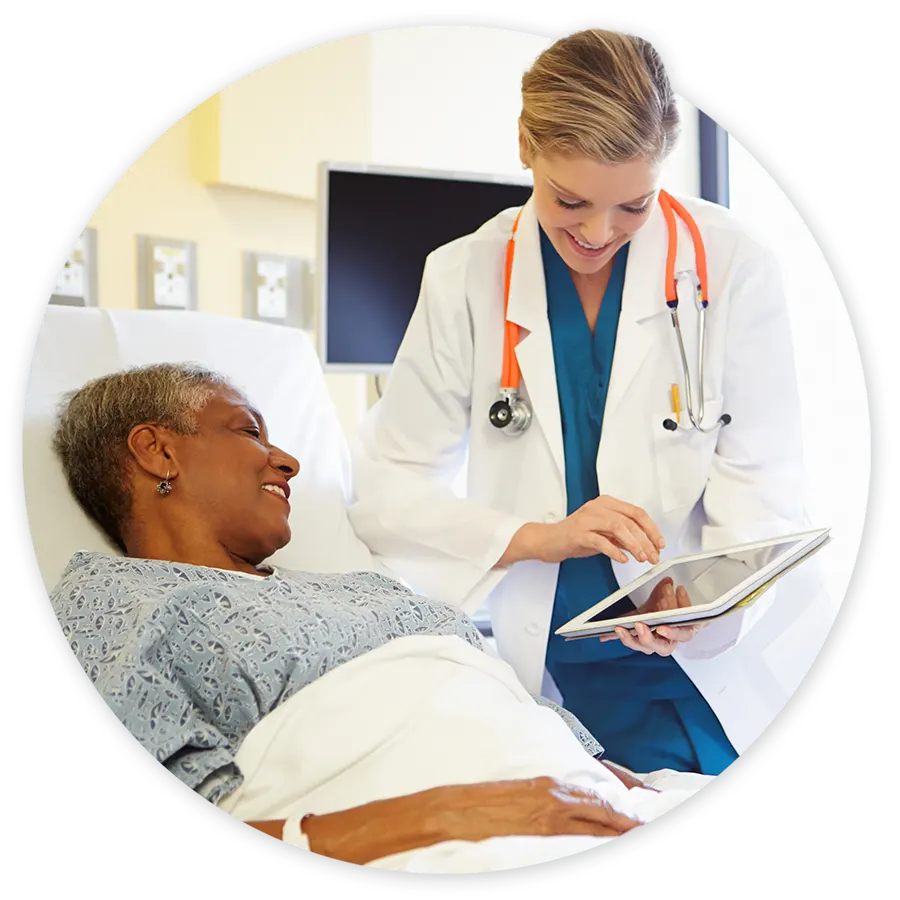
89,110,315,316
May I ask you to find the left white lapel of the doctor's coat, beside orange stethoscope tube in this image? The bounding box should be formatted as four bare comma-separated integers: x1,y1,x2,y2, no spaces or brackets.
507,199,565,483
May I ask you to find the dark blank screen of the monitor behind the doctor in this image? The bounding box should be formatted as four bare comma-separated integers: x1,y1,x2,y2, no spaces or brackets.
323,170,531,369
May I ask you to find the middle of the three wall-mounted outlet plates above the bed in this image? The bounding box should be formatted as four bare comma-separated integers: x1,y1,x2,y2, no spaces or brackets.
137,234,197,310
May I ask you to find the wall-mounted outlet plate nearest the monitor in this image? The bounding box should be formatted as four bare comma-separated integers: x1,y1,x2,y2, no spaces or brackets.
244,251,313,331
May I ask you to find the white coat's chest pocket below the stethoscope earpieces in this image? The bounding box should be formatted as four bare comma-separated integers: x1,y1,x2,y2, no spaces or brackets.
650,397,723,513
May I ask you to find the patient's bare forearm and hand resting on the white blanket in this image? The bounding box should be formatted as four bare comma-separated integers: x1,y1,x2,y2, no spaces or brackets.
247,778,641,865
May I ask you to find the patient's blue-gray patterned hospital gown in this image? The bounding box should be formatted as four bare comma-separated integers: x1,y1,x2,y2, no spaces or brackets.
50,553,602,802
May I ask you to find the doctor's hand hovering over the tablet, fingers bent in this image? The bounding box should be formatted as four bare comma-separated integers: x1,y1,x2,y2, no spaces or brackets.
497,496,666,566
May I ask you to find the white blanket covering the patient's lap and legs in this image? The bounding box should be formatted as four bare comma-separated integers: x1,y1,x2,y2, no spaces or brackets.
220,636,710,872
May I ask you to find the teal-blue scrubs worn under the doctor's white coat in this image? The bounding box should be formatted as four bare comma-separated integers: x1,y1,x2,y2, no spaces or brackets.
541,230,737,775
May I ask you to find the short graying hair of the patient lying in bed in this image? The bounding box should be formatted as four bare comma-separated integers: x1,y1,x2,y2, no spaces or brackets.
53,363,237,551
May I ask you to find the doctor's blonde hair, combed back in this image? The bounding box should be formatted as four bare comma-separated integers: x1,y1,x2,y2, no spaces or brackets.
519,27,679,165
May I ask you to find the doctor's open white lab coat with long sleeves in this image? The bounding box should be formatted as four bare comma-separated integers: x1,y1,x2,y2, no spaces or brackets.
350,198,828,752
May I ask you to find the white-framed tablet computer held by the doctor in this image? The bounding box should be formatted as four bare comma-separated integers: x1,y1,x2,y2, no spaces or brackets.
556,528,830,640
